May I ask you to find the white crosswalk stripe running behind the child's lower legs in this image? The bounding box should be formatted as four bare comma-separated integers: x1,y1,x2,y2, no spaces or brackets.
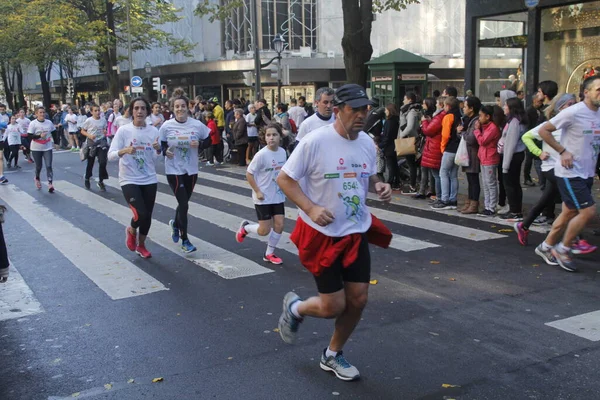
104,181,298,255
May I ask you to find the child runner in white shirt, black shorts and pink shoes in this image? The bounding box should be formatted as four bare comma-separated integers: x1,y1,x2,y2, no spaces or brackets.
235,122,287,265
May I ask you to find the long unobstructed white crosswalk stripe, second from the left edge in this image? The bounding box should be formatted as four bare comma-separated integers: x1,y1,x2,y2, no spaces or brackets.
2,185,168,300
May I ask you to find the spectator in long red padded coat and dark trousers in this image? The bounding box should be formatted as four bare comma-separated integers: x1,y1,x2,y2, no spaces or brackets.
415,97,446,200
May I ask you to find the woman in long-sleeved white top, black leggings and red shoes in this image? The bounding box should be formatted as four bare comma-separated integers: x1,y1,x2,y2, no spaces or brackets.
108,97,160,258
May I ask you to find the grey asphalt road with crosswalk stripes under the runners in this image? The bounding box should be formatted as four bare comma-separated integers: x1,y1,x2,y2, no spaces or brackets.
0,152,600,400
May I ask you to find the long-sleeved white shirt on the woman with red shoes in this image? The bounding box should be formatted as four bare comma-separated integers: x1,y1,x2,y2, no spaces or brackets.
108,124,158,186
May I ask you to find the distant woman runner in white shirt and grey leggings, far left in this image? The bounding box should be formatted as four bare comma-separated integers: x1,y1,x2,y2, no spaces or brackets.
27,106,56,193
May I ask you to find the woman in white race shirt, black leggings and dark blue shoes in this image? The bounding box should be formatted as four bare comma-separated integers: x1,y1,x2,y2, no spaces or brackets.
155,88,211,253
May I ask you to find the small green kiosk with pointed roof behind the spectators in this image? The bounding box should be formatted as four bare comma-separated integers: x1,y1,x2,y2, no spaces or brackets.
366,49,433,107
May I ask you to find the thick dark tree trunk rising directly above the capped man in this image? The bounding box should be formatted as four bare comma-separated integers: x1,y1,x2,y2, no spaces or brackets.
342,0,373,87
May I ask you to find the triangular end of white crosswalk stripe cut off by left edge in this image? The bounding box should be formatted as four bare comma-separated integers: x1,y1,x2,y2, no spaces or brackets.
0,260,44,321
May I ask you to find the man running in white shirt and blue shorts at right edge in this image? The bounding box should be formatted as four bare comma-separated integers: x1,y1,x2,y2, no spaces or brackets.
535,75,600,272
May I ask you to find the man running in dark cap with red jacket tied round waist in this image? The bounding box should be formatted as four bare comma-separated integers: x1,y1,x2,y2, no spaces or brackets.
277,84,392,381
